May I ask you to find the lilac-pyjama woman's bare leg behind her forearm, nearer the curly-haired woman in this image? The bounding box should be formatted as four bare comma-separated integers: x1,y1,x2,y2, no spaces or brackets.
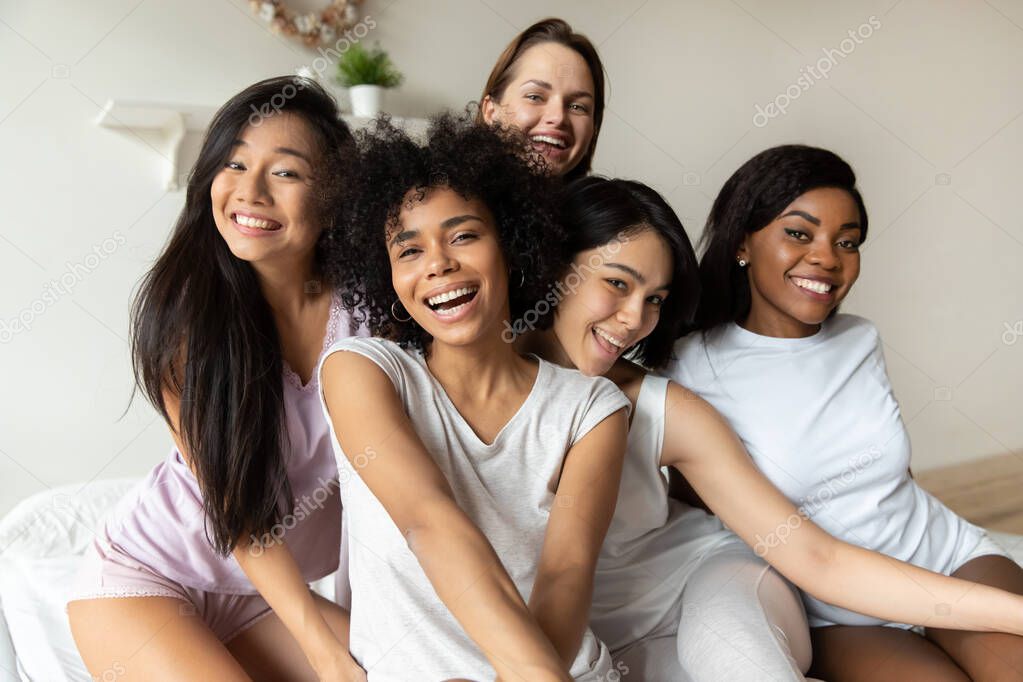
227,594,358,681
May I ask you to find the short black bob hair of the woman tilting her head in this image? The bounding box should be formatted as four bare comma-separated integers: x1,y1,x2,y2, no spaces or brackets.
545,176,700,369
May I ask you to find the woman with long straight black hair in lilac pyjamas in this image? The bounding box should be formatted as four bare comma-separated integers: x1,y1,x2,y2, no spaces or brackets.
68,78,368,680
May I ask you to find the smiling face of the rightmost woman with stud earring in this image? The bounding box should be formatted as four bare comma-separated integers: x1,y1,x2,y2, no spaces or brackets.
737,187,861,337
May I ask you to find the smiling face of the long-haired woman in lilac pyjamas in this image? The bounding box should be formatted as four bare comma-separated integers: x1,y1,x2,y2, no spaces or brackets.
210,113,322,264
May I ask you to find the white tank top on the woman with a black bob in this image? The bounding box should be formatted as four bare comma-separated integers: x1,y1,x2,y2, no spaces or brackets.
589,374,736,651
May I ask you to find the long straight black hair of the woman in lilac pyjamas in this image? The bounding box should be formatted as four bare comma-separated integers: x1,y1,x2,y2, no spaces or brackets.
131,77,354,555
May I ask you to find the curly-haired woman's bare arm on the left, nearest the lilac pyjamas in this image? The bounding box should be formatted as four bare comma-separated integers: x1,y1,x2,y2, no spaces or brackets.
321,352,571,682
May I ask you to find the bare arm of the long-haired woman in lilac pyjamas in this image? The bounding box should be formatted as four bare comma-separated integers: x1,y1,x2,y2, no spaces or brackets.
164,391,361,679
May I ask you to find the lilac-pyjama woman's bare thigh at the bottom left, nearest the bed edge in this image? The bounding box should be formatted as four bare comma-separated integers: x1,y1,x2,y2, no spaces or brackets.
68,597,249,682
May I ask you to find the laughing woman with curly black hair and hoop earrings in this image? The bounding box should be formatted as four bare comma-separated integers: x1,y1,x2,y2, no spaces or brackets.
320,116,628,682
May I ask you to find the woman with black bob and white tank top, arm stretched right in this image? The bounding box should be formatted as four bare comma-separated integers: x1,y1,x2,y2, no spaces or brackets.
516,177,1023,680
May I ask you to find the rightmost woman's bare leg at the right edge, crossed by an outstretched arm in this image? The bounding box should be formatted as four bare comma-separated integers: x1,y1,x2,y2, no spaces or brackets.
927,554,1023,682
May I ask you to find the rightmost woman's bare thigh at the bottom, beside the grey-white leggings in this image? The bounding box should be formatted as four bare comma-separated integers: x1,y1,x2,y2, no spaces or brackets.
810,625,970,682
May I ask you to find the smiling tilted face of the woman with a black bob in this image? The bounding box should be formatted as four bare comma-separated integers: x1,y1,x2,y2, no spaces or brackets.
553,229,672,376
